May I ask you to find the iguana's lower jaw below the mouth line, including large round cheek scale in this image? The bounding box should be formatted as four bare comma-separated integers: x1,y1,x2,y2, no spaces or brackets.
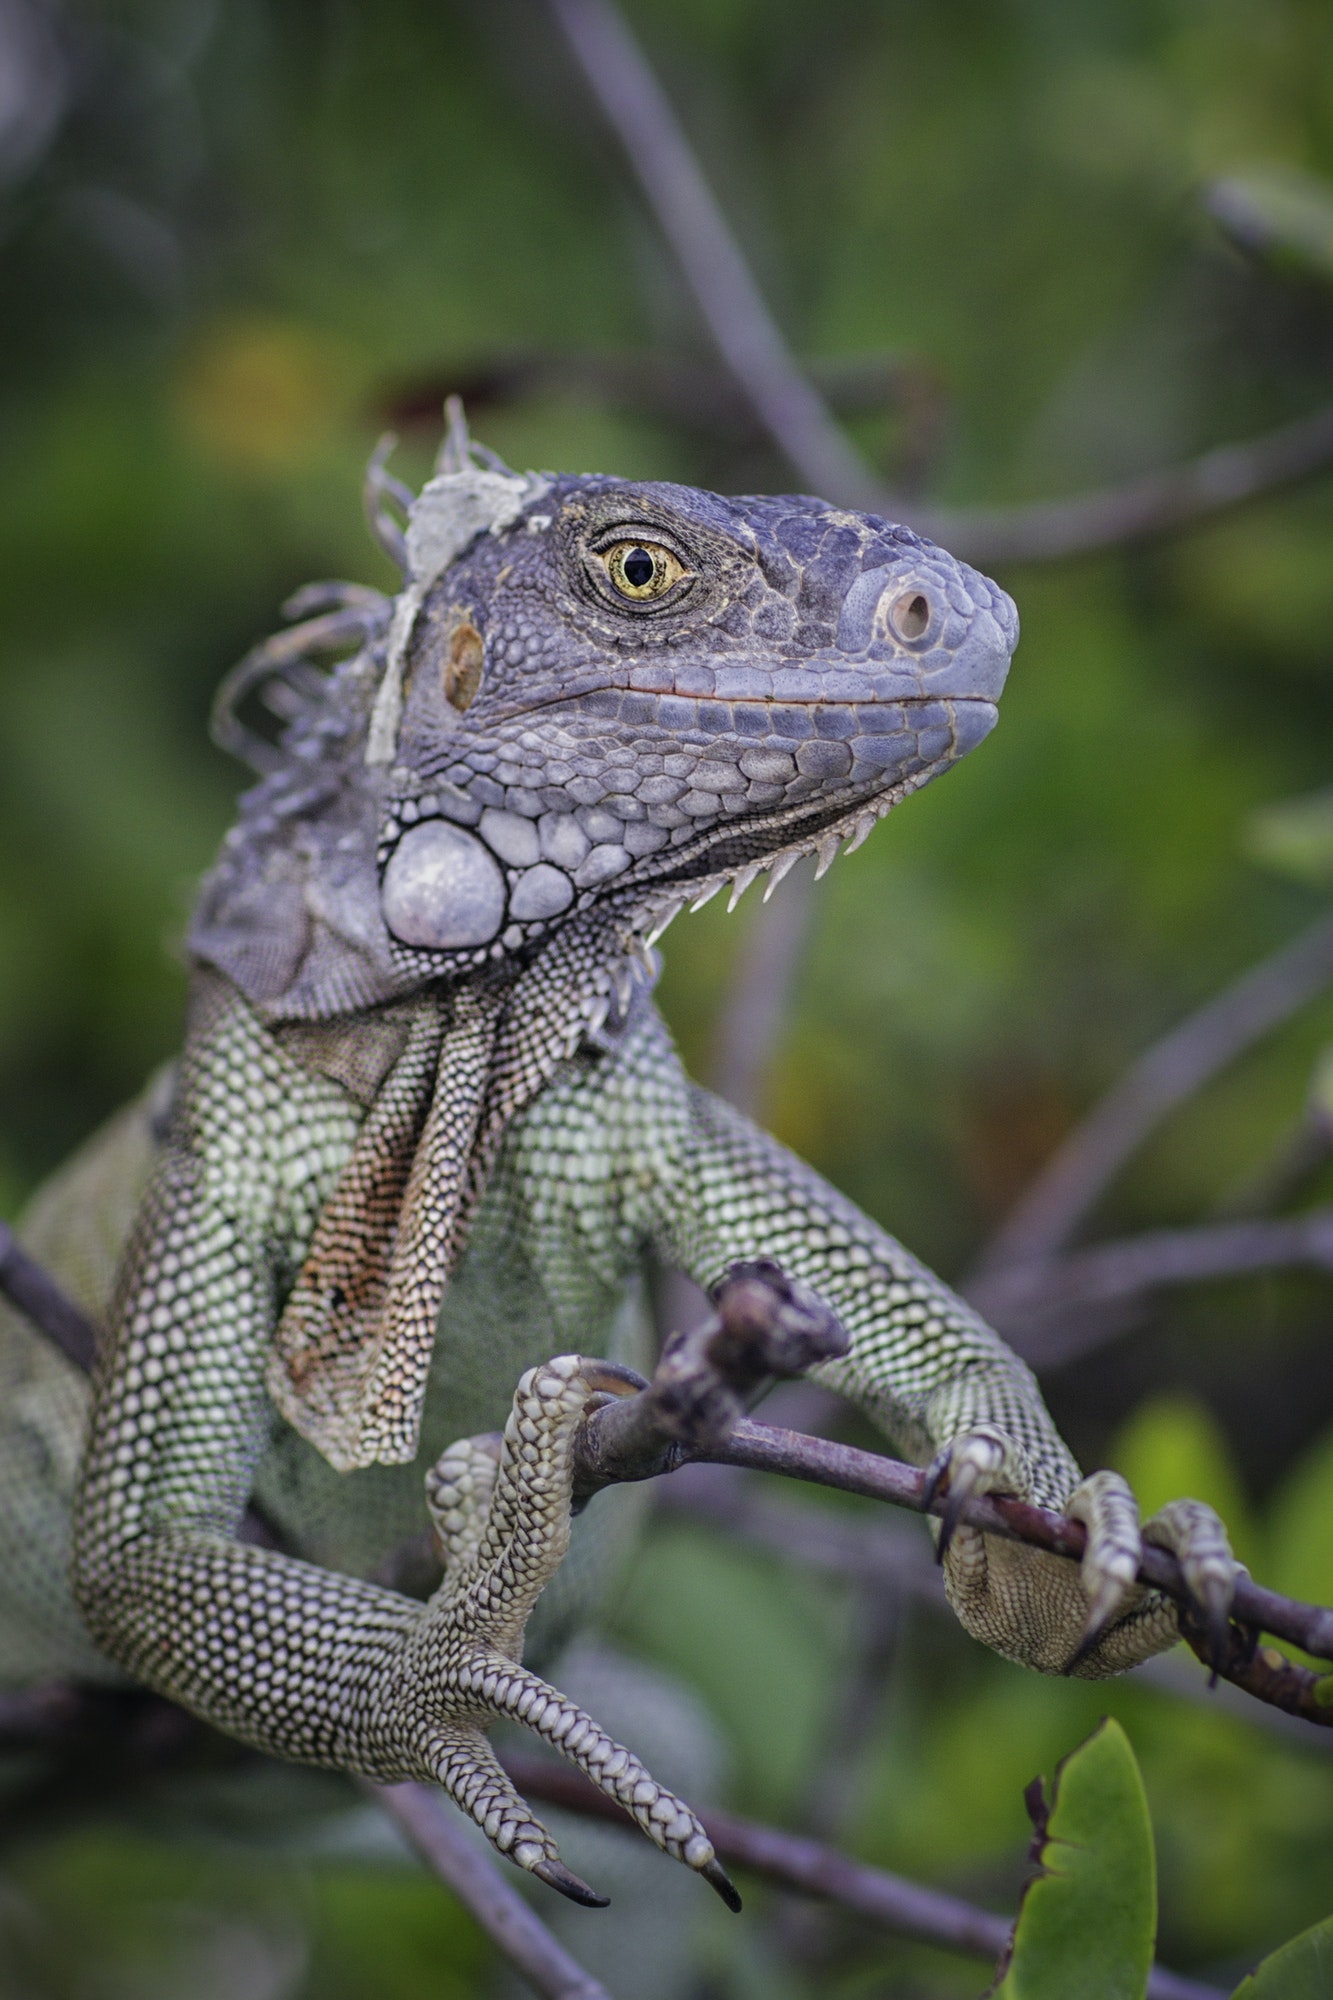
368,692,997,964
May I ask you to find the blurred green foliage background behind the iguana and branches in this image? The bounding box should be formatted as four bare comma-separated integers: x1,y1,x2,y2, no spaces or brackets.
0,0,1333,2000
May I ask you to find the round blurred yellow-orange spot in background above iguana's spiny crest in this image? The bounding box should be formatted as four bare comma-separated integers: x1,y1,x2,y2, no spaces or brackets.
174,320,344,470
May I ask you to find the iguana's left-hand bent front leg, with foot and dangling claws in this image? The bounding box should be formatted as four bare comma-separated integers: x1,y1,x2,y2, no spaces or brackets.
72,1004,735,1900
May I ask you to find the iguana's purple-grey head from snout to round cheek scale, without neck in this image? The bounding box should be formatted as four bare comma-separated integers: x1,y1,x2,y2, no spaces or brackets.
370,456,1019,972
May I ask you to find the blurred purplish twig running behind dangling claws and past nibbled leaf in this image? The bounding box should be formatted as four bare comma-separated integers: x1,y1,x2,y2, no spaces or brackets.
502,1752,1221,2000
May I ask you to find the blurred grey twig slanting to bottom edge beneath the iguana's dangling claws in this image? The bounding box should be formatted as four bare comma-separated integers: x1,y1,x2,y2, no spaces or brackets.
358,1780,610,2000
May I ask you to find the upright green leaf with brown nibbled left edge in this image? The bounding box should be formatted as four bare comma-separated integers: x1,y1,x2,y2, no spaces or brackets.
995,1720,1157,2000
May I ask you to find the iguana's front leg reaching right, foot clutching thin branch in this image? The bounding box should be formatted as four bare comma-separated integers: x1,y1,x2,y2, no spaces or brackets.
652,1090,1235,1678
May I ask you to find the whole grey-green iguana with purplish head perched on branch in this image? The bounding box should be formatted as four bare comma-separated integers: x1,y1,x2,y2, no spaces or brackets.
0,418,1233,1900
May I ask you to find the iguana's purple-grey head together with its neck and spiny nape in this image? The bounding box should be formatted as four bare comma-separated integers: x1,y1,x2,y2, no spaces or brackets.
190,434,1019,1034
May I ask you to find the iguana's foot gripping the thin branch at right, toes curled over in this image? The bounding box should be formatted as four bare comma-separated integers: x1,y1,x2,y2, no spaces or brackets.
927,1424,1237,1680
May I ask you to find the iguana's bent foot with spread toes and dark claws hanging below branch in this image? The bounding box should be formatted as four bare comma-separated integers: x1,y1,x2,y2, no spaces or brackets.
400,1354,741,1910
